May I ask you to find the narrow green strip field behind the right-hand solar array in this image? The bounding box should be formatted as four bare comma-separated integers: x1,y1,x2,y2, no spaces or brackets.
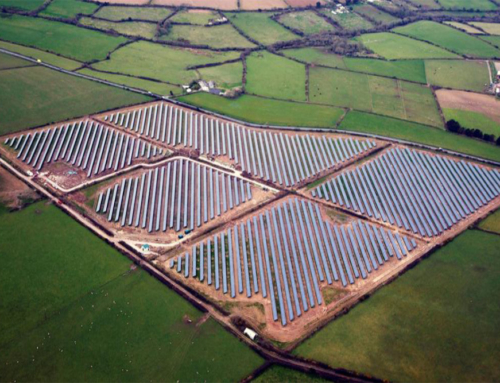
339,111,500,161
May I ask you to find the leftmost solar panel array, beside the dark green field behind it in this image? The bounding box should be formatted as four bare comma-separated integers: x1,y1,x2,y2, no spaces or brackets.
5,120,163,177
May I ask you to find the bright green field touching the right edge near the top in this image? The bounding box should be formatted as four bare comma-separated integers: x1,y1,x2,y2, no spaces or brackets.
394,21,500,58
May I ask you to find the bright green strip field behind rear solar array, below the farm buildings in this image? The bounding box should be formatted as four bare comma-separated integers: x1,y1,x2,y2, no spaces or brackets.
179,93,344,128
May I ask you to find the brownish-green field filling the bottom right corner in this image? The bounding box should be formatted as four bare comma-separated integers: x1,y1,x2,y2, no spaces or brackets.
295,230,500,382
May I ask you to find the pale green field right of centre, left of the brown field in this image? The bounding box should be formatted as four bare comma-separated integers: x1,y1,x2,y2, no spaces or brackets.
309,68,442,127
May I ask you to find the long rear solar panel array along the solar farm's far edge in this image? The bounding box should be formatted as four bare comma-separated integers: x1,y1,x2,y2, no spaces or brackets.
104,103,376,187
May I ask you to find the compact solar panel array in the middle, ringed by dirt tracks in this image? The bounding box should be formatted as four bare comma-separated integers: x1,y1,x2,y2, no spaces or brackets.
96,159,252,233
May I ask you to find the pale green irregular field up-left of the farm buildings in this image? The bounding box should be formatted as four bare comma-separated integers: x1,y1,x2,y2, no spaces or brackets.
94,41,240,84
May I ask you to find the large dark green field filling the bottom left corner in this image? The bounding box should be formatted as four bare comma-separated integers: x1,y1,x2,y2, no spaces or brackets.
0,202,262,382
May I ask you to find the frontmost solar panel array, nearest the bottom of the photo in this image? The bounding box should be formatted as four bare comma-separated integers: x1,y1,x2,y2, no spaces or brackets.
170,199,417,326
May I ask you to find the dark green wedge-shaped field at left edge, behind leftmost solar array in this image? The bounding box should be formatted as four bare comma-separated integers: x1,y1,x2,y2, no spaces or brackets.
0,67,149,134
